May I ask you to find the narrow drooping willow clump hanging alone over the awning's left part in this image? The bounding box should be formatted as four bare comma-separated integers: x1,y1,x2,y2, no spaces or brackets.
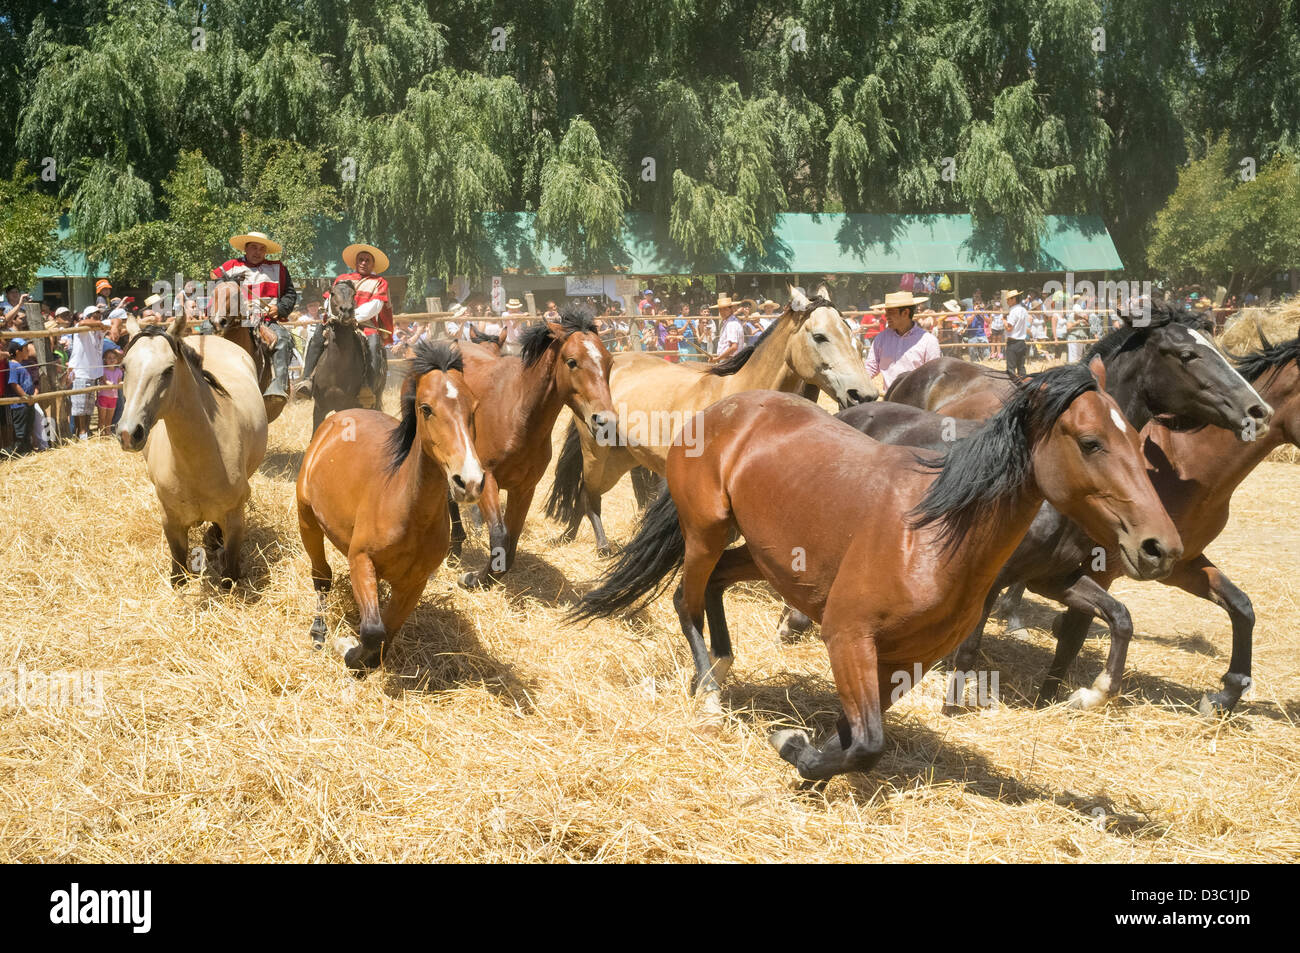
537,118,628,274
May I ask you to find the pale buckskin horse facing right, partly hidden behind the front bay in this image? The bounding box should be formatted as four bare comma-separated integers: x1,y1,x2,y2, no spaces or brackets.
546,285,878,554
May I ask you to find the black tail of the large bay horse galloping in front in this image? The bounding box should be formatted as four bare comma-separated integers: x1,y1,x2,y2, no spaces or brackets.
566,488,686,621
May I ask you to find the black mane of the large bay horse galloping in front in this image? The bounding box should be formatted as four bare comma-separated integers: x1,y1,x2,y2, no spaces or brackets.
909,364,1099,551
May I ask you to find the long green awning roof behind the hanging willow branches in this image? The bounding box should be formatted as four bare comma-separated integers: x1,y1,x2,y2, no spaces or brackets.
481,212,1123,274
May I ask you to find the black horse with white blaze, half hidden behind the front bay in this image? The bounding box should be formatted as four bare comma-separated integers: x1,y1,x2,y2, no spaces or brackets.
953,307,1273,707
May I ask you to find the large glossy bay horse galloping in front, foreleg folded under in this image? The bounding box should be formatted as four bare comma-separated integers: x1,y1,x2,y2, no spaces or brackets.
573,361,1182,780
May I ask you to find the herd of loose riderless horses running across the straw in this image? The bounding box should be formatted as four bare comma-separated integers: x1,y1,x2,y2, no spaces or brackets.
111,280,1300,781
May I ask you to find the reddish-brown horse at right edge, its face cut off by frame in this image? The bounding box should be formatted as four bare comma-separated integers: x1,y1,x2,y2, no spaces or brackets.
998,330,1300,715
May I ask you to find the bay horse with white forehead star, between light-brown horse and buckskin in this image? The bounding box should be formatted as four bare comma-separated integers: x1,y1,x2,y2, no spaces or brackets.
451,304,618,589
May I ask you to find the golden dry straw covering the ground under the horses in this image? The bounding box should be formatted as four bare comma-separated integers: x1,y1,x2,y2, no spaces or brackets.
0,382,1300,862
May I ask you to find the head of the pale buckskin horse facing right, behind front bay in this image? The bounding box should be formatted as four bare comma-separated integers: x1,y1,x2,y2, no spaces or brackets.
785,283,880,410
